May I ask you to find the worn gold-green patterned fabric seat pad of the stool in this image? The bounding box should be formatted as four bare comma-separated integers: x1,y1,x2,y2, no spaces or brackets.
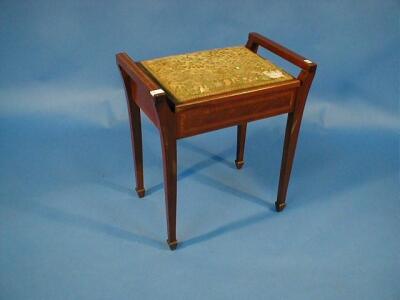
141,46,294,103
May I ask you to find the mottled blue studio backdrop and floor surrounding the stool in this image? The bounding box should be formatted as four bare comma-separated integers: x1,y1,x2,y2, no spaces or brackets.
0,0,400,300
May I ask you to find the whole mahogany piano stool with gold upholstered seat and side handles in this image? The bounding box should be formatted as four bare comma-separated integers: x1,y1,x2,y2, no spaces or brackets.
116,33,317,250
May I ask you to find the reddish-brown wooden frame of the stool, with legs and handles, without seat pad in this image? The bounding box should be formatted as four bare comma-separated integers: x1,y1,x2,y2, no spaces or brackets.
116,32,317,250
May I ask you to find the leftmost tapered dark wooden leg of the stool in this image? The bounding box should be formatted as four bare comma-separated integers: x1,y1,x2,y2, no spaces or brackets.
121,70,145,198
